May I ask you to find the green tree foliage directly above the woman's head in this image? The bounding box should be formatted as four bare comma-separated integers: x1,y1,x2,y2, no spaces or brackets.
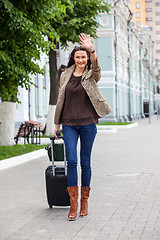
52,0,111,47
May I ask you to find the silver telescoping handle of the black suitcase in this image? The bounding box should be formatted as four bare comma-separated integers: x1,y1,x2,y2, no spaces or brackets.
50,130,67,176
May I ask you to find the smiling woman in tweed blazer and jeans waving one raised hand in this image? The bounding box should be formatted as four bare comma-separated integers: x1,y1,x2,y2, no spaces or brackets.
54,33,111,220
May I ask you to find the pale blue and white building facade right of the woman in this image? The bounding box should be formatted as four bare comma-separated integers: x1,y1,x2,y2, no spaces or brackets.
97,0,159,121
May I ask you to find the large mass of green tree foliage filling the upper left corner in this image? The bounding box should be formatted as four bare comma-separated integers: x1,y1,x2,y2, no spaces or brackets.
0,0,65,101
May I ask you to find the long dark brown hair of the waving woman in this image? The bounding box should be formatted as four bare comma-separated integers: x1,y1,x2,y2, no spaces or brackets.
67,46,91,69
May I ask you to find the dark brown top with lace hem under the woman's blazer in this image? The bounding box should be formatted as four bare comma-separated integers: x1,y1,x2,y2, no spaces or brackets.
61,74,99,125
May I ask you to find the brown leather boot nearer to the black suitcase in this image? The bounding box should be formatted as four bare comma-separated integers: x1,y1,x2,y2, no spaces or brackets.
67,186,78,220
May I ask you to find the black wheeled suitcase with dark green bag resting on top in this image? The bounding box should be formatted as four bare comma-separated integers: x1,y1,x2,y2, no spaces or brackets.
45,133,70,208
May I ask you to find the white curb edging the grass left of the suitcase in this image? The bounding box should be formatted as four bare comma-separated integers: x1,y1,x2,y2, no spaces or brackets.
0,149,47,170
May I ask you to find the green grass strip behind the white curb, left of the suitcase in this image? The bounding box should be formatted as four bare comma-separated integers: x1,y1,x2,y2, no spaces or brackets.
0,144,46,160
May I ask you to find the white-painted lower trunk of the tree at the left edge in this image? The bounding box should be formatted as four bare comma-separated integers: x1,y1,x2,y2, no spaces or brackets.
0,102,16,146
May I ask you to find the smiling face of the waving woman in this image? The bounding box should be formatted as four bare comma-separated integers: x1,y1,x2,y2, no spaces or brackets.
74,50,89,69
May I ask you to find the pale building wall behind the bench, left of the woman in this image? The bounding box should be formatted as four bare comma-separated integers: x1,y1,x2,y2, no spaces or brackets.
15,54,50,128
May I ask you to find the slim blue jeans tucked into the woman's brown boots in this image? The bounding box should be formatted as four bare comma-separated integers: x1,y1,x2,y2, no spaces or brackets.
63,124,97,187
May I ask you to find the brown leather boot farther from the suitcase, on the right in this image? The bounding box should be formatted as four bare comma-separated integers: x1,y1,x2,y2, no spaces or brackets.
80,187,91,217
